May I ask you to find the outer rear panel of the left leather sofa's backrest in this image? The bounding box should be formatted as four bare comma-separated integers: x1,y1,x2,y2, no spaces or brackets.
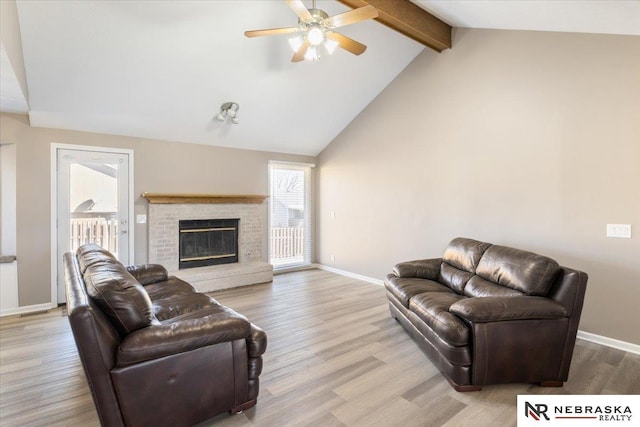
63,252,123,426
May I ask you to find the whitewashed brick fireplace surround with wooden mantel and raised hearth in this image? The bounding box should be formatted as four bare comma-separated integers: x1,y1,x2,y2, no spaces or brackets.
143,193,273,292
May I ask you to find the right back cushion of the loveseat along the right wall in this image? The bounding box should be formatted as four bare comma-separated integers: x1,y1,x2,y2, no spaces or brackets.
476,245,560,296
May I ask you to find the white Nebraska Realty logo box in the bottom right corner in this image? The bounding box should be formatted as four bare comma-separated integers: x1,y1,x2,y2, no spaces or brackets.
518,394,640,427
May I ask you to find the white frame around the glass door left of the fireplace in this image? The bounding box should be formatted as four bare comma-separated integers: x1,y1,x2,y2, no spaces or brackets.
50,142,135,308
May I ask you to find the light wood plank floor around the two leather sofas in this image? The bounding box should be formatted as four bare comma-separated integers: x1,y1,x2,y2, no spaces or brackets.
0,270,640,427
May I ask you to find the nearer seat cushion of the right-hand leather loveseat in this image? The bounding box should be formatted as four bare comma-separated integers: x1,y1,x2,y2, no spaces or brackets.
409,292,469,346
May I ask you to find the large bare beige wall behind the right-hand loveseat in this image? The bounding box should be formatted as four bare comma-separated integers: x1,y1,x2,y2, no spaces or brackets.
317,29,640,344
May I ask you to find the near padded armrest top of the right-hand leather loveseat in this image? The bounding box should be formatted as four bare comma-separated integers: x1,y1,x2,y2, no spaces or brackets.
449,296,567,323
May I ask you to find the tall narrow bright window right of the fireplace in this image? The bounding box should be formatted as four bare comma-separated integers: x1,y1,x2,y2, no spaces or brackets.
269,162,313,269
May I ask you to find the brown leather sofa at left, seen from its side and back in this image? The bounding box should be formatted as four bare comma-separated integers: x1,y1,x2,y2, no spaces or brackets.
64,245,267,426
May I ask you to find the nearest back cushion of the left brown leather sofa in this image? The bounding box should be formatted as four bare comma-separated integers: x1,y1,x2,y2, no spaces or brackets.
83,260,157,336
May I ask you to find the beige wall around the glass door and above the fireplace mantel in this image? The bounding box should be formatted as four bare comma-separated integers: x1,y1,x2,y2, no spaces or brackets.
0,114,314,306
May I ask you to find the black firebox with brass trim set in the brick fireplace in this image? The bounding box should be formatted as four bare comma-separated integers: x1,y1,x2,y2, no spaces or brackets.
178,219,240,269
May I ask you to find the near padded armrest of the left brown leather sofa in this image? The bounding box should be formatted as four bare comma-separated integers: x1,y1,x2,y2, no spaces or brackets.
117,306,251,368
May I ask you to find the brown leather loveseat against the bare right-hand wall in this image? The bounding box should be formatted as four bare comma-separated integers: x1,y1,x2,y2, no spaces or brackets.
385,238,587,391
